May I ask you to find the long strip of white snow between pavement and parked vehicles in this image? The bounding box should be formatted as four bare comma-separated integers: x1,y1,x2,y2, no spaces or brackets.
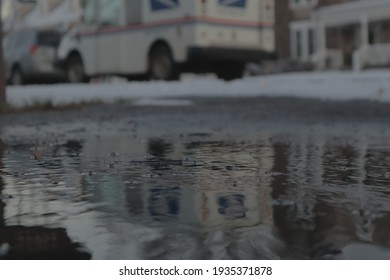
7,70,390,108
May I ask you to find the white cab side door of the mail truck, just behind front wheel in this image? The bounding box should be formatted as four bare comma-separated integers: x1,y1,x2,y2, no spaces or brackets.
97,0,124,74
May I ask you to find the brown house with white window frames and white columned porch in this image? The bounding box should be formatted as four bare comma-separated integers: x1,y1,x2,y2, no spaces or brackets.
275,0,390,70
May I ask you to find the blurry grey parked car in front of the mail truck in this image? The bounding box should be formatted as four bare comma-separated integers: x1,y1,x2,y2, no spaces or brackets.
4,29,65,85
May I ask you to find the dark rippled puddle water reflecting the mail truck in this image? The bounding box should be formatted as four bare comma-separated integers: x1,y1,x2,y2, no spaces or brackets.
0,119,390,259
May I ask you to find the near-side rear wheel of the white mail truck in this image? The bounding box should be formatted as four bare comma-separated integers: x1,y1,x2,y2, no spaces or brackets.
149,45,179,81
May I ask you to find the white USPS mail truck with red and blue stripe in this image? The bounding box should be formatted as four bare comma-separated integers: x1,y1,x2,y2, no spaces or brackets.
58,0,274,83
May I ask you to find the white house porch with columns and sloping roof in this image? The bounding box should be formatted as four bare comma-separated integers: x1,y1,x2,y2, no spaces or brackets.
312,0,390,70
